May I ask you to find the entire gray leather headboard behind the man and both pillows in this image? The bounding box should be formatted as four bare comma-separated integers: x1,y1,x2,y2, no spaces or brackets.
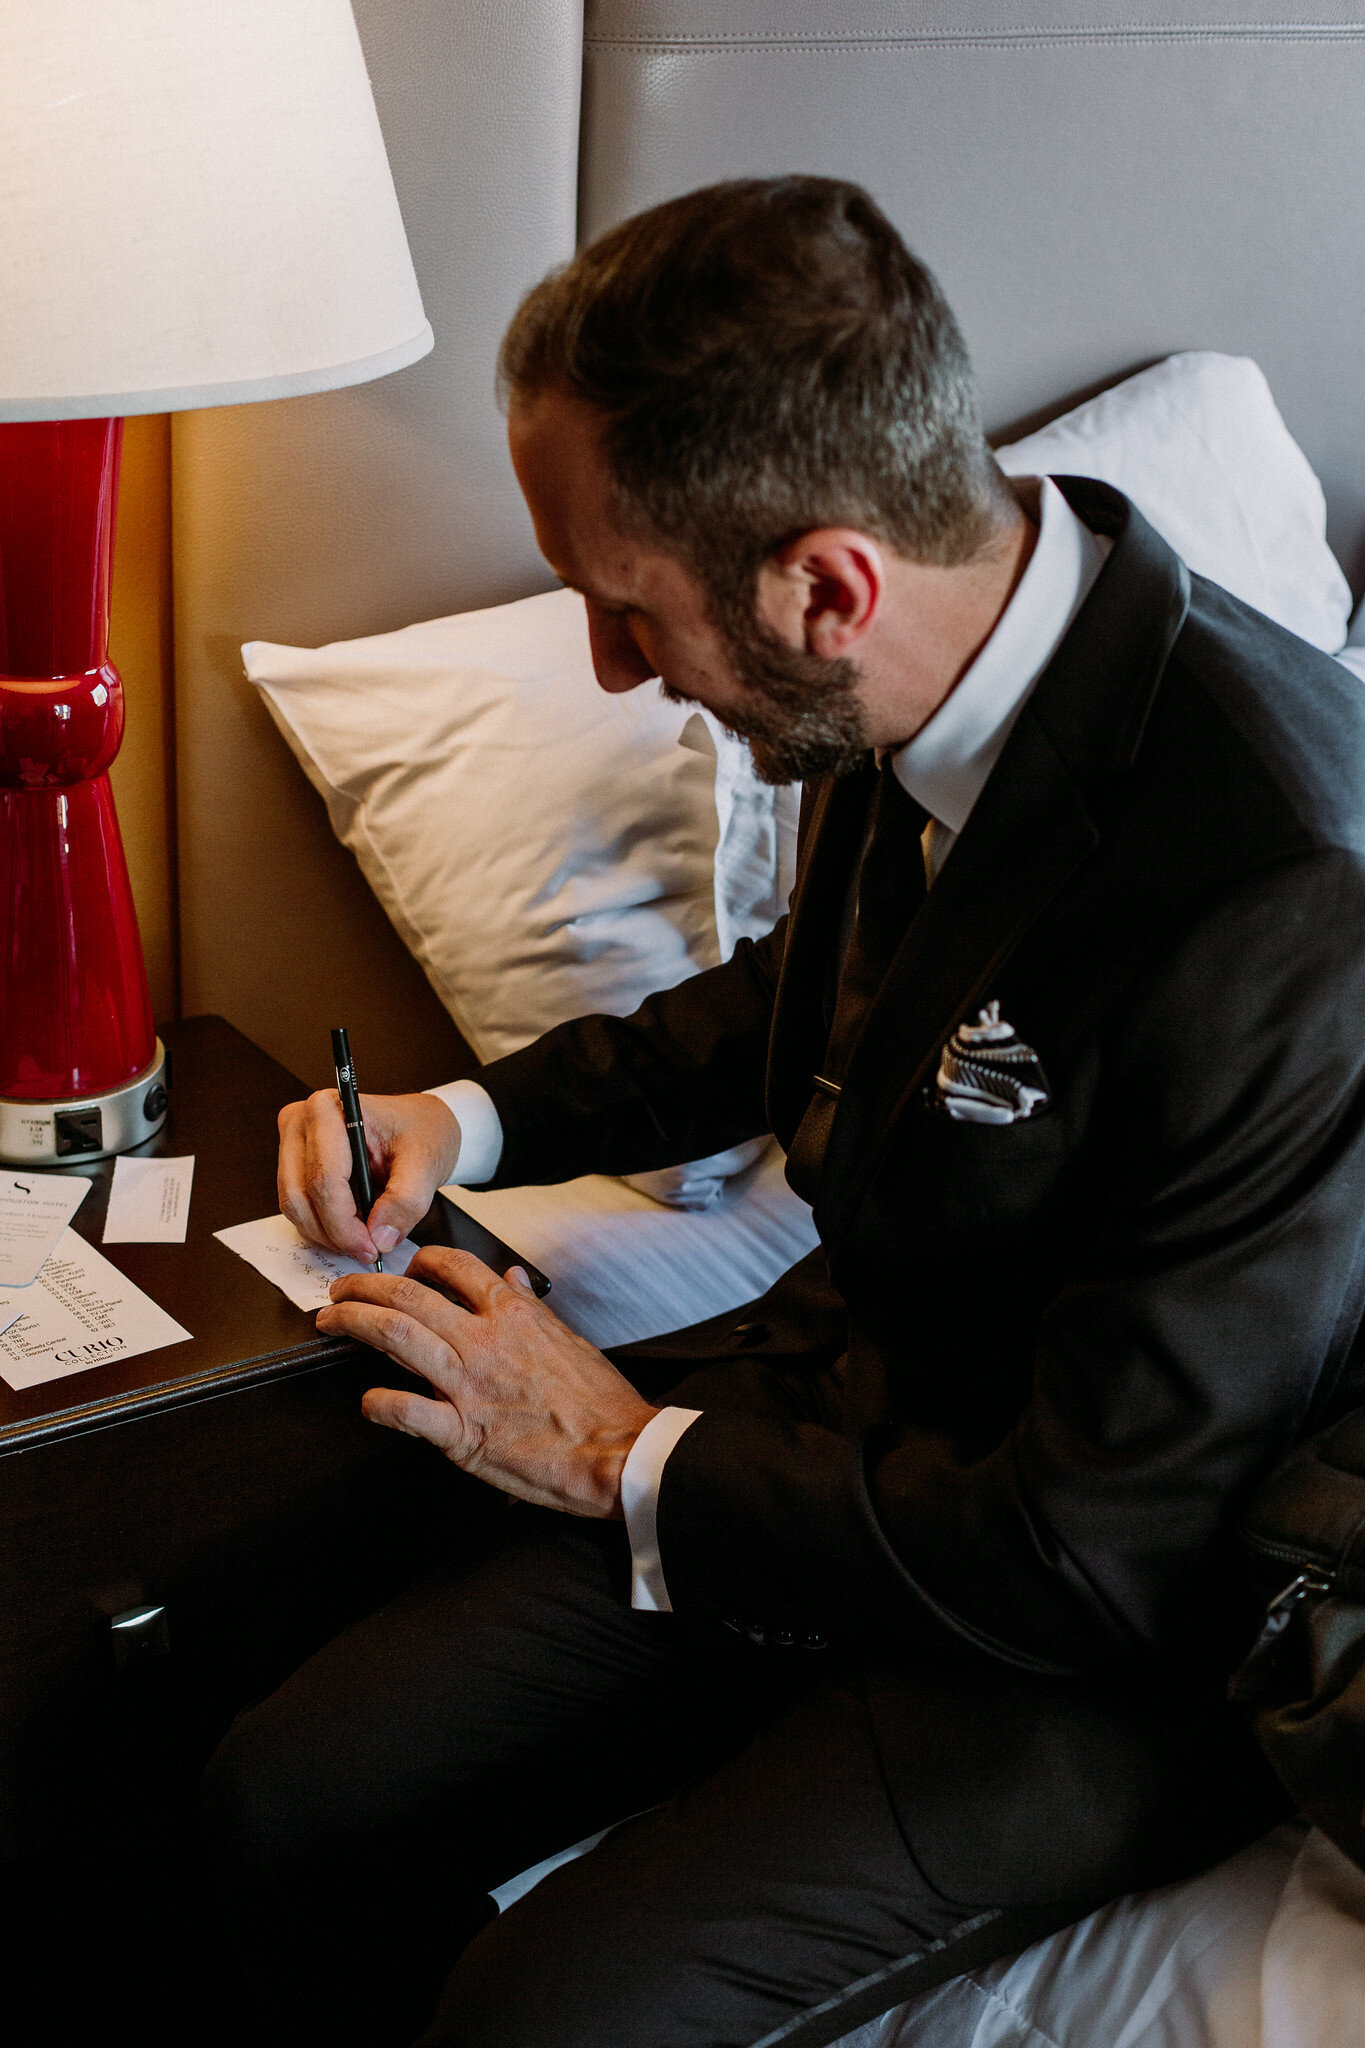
176,0,1365,1085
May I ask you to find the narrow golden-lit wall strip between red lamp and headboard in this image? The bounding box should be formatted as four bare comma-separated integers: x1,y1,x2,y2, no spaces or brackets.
108,414,180,1020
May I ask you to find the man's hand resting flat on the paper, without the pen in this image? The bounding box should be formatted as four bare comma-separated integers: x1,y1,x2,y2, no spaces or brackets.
317,1245,659,1518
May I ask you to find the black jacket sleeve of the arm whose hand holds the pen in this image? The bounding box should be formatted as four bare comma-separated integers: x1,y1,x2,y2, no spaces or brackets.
479,918,786,1188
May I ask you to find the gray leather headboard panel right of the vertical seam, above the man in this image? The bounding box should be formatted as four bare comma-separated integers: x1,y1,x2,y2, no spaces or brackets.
579,0,1365,577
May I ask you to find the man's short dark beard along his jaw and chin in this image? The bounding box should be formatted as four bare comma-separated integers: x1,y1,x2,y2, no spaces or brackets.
659,621,870,782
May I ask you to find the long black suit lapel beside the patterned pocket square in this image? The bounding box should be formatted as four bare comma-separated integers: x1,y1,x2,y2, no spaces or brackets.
810,477,1189,1249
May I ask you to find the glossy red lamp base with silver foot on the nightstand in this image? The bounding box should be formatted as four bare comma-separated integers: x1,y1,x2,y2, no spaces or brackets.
0,420,166,1165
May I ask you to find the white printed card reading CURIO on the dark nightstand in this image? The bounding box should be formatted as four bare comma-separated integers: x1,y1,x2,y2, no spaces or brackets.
0,1231,190,1389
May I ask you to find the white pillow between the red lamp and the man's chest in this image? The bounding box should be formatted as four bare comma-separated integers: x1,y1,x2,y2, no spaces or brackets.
241,590,718,1079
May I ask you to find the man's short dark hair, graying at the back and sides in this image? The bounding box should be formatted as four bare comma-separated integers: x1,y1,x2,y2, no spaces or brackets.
499,176,1011,616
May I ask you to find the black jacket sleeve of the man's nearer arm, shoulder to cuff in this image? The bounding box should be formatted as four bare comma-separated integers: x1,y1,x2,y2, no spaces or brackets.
659,852,1365,1671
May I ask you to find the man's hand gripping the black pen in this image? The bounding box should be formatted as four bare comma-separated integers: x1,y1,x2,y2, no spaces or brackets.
278,1087,460,1266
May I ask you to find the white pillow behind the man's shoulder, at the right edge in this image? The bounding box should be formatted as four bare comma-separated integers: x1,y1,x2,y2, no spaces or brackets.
997,352,1351,653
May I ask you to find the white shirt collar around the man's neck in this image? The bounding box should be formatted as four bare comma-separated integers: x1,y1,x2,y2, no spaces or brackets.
892,477,1109,834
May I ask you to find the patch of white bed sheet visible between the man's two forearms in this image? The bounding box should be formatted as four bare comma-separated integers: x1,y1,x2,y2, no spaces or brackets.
444,1141,817,1348
